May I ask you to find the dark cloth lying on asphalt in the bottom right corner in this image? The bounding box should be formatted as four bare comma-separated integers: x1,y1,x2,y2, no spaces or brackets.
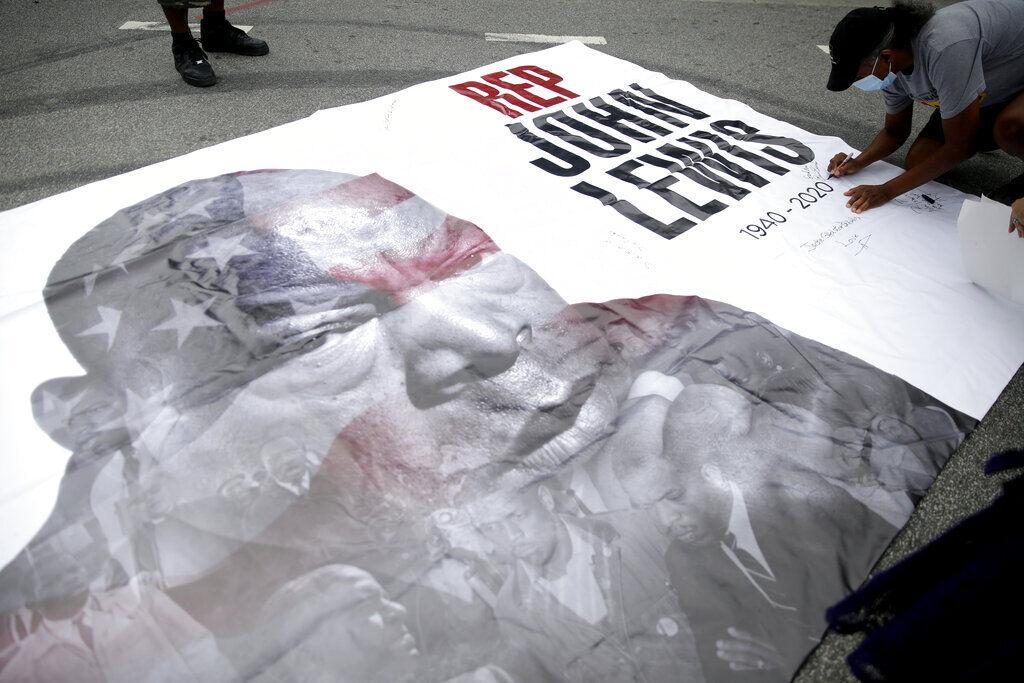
827,450,1024,681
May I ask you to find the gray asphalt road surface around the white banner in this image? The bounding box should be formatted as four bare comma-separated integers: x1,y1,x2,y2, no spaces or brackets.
0,0,1024,681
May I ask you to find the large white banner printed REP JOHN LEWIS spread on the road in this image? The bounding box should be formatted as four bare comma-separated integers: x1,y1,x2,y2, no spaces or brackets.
0,44,1024,680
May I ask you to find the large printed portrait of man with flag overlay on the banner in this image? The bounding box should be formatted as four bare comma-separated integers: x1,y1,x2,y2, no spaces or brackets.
0,170,973,683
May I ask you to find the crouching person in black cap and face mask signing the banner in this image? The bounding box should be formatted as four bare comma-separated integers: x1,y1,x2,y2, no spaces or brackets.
827,0,1024,213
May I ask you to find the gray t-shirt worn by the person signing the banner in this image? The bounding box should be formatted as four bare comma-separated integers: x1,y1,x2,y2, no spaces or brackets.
882,0,1024,119
